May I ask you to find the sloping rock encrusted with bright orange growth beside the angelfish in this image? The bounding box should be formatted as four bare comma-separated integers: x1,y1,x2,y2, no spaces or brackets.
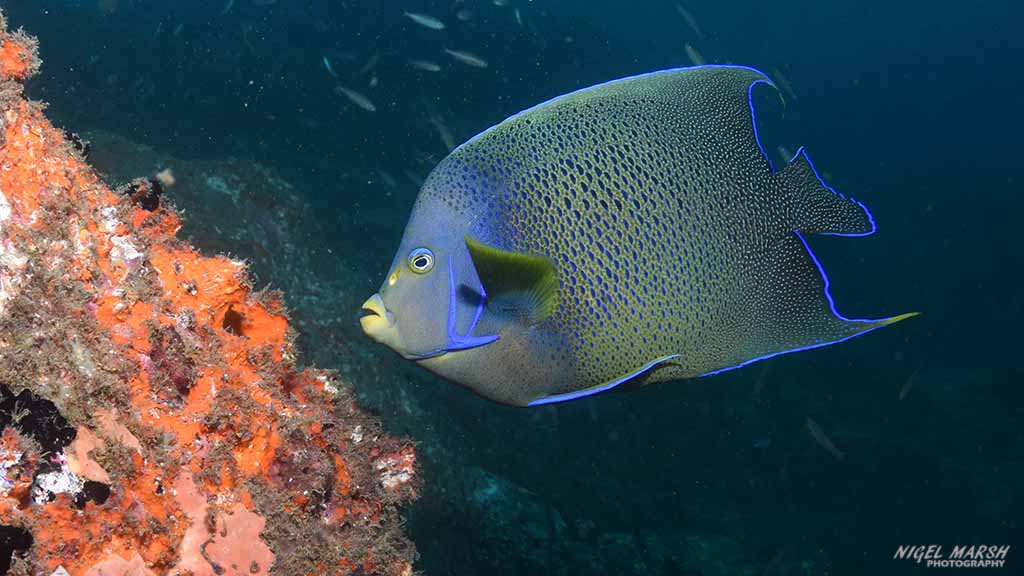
0,15,418,576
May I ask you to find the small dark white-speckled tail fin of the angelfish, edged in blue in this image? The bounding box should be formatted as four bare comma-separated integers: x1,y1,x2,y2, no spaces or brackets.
775,147,878,236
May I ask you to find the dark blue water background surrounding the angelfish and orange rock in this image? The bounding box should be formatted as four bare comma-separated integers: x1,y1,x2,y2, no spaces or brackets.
0,0,1024,576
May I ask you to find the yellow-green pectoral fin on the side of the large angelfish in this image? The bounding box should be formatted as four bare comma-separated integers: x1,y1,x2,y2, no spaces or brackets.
466,236,558,324
